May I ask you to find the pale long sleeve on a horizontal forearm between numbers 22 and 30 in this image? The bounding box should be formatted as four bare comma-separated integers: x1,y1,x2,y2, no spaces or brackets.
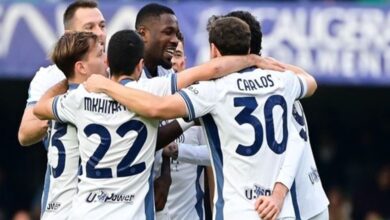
177,144,211,166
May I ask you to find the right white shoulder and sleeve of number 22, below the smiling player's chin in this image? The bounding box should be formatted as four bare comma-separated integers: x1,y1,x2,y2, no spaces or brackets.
133,74,177,96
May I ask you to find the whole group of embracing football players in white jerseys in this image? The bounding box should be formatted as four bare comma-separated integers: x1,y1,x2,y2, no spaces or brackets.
18,1,328,219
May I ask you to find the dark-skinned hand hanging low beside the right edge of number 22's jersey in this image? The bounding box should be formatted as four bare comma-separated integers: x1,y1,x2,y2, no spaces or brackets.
154,175,172,211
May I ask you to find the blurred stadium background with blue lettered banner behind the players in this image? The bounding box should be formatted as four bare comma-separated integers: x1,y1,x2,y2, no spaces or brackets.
0,0,390,220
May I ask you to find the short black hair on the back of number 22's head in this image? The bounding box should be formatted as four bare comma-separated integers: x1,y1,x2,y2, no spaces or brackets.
107,30,144,76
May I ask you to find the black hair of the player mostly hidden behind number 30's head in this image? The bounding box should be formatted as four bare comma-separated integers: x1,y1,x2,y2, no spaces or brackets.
225,11,263,54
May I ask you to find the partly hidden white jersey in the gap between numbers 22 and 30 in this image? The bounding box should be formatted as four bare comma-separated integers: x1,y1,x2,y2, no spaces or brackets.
167,126,207,220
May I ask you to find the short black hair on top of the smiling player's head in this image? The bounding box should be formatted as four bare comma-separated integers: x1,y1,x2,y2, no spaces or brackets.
135,3,175,30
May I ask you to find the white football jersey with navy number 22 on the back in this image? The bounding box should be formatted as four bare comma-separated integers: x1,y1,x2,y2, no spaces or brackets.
53,75,176,219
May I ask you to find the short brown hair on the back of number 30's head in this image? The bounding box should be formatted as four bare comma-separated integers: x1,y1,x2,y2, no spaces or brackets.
209,17,251,55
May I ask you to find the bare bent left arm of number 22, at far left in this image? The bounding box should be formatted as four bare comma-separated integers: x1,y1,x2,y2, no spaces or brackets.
34,80,68,120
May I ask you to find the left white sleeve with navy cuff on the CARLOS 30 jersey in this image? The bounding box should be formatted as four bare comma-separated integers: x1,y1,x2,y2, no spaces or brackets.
178,81,219,121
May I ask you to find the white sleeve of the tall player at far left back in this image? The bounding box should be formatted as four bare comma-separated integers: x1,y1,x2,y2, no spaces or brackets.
27,65,65,106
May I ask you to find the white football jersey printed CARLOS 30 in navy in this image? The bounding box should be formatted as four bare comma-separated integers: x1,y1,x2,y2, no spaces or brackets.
179,68,307,219
